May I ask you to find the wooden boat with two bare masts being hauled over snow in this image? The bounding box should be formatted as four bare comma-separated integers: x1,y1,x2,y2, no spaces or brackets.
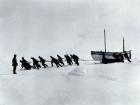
91,29,131,63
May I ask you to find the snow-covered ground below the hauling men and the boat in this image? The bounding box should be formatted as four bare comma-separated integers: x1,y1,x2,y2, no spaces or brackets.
0,56,140,105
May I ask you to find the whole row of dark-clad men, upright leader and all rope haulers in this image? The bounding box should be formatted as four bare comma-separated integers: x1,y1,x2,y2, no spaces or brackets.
12,54,79,74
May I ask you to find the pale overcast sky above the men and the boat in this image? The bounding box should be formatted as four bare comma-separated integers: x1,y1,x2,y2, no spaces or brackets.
0,0,140,57
